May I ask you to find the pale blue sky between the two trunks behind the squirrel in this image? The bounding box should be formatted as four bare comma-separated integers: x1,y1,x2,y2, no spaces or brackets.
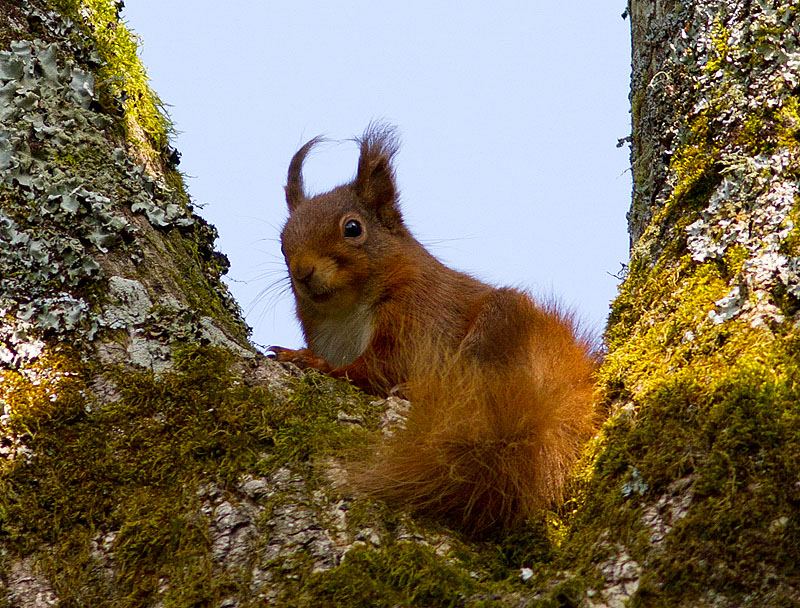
123,0,631,346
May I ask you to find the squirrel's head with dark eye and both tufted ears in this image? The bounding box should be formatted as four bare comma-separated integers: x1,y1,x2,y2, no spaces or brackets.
281,125,412,312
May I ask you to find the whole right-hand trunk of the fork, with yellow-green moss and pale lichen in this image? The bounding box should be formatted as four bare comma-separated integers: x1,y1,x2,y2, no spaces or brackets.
566,0,800,607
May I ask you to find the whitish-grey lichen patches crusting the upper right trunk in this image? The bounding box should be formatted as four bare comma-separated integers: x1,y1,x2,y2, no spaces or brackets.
630,2,800,329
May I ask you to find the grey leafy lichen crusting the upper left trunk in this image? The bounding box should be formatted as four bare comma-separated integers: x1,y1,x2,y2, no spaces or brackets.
0,6,252,370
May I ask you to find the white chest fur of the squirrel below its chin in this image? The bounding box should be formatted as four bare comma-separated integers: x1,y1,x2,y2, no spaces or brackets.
307,306,372,367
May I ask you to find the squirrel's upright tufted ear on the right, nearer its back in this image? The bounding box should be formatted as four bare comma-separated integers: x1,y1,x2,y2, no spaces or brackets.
353,124,403,228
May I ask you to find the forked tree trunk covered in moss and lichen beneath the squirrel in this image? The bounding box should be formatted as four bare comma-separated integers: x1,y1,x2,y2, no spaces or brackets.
0,0,800,608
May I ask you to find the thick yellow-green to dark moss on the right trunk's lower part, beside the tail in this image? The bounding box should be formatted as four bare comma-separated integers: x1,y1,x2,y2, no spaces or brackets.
588,186,800,607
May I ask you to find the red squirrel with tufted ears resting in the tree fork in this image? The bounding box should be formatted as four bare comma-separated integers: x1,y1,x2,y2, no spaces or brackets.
271,124,596,533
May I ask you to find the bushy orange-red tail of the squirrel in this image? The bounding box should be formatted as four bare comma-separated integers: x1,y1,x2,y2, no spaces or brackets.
351,314,596,533
